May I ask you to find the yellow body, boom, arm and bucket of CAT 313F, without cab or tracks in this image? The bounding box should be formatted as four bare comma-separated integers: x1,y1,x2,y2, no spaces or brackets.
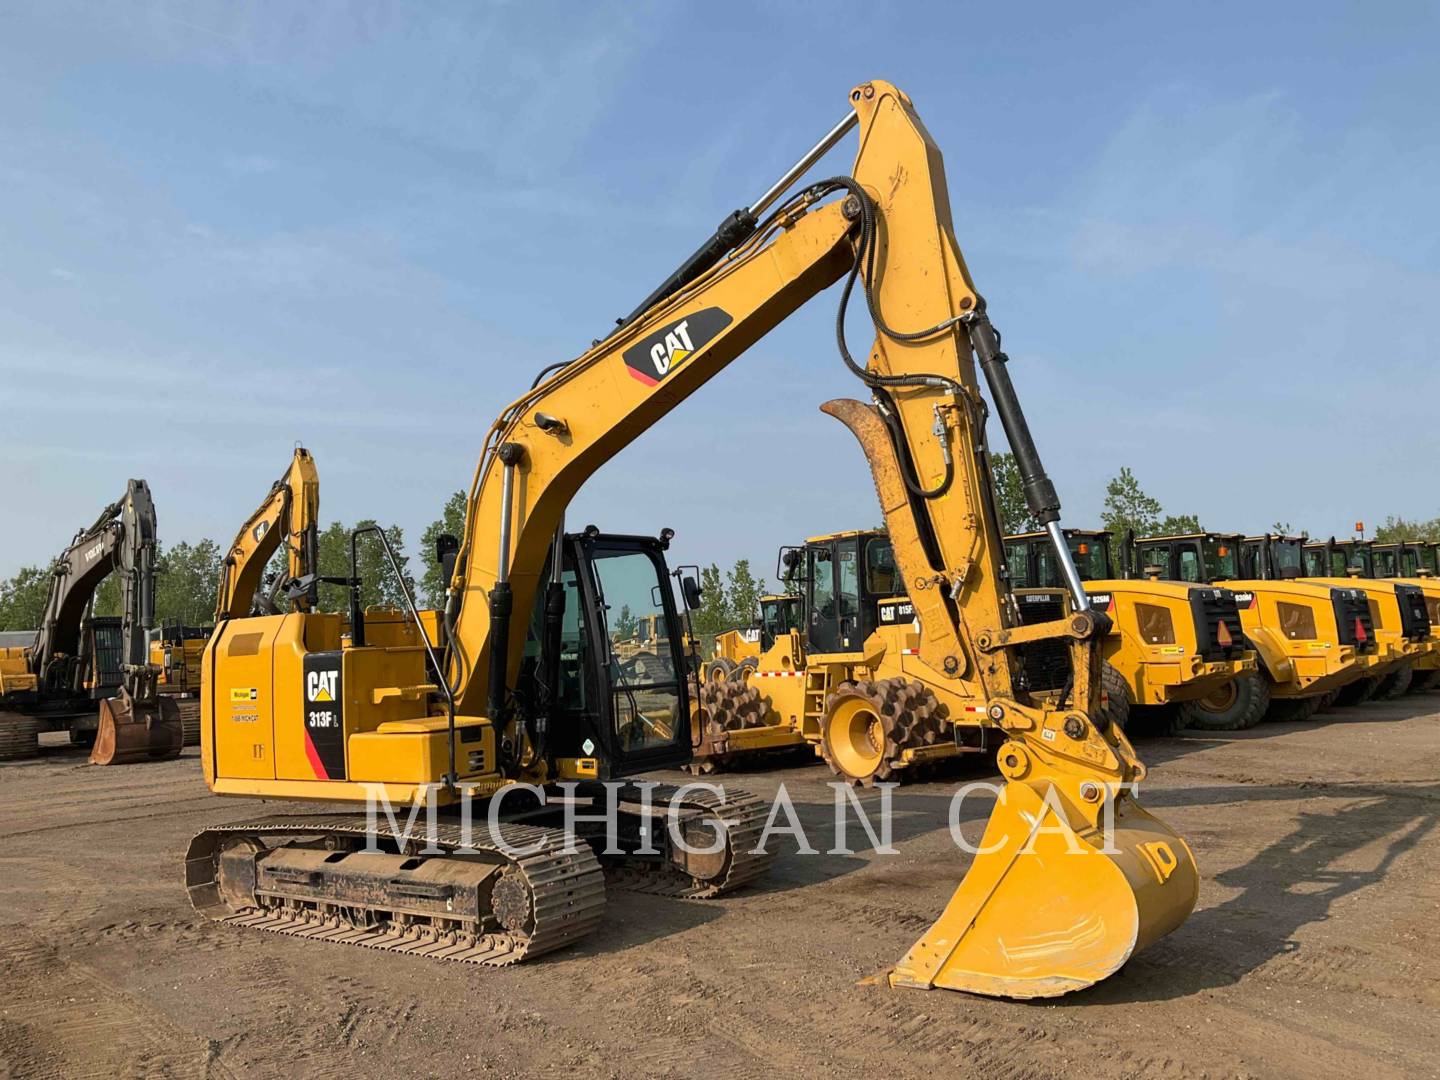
200,81,1197,996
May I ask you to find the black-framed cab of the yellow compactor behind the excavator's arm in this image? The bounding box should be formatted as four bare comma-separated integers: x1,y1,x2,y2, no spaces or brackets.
782,530,892,655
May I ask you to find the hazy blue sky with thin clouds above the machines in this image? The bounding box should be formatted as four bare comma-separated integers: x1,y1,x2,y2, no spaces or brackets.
0,0,1440,575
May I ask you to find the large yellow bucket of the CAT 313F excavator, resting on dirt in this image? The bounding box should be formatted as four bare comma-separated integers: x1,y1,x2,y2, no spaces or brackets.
890,780,1200,998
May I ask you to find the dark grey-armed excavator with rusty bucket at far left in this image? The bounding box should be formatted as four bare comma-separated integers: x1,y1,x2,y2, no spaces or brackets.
0,480,183,765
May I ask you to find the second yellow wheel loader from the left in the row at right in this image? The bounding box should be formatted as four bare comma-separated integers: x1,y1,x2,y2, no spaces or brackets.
1125,533,1384,732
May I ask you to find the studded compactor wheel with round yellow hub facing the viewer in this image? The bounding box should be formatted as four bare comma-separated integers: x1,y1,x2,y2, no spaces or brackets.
819,677,946,788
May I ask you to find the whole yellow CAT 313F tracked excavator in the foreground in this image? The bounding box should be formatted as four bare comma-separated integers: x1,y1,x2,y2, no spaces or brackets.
186,81,1198,998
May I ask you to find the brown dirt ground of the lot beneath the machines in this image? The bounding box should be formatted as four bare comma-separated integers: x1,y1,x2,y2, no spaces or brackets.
0,694,1440,1080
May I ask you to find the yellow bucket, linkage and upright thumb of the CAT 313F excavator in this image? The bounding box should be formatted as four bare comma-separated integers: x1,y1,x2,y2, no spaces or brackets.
821,403,1200,998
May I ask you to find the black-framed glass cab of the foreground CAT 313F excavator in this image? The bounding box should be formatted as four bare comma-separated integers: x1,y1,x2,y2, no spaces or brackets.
517,528,697,779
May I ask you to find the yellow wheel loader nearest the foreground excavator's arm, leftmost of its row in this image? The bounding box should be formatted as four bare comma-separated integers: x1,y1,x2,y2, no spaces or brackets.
1005,528,1256,730
